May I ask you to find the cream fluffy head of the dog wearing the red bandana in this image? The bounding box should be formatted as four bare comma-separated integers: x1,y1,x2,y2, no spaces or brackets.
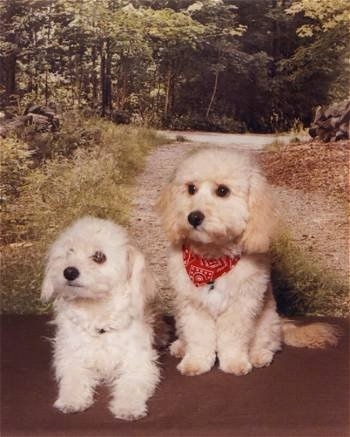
157,149,275,253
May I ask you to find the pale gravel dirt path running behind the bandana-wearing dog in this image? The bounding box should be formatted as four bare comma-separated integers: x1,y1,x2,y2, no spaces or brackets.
130,142,349,306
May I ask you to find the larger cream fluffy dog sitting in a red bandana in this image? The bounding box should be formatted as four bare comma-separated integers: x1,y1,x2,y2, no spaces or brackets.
157,149,336,375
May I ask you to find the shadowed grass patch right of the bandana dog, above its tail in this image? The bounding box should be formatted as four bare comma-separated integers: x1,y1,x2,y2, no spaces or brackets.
272,231,349,317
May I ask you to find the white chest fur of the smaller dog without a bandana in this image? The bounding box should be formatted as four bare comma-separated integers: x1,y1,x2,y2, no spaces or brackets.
55,299,151,379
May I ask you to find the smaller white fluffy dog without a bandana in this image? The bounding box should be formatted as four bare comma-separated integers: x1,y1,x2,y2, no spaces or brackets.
42,217,159,420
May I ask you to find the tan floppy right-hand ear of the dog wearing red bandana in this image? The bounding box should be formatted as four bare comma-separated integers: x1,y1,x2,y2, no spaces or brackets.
241,171,277,253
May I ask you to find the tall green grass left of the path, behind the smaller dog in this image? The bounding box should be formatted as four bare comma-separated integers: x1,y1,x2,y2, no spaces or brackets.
0,115,166,314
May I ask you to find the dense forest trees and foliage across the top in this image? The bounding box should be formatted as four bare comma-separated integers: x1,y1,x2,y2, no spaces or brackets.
0,0,350,131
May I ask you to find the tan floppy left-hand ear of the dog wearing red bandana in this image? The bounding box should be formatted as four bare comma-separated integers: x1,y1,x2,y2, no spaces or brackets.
155,182,182,243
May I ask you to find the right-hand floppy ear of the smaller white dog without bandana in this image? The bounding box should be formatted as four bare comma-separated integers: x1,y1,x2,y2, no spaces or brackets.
127,245,156,317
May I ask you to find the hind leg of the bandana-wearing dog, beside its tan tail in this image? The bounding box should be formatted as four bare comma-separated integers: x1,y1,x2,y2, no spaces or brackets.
249,289,282,367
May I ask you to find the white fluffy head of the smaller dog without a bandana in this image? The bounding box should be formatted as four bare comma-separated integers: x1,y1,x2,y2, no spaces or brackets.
42,217,152,314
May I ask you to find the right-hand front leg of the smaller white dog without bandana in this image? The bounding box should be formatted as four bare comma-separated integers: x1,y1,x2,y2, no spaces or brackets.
109,344,159,420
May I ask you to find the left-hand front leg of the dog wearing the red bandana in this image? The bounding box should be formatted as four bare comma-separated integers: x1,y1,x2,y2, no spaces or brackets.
176,304,216,376
